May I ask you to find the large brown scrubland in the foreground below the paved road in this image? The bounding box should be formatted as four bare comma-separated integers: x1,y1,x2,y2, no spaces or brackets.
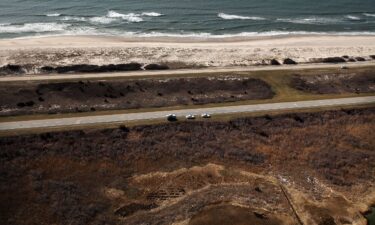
0,108,375,225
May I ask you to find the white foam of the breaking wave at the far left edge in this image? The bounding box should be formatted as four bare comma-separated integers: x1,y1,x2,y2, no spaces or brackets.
0,23,70,34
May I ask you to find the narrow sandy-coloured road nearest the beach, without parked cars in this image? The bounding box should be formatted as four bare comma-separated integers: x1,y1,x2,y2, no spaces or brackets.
0,61,375,82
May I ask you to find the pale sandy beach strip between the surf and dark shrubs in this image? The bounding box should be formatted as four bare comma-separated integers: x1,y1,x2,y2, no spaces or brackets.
0,35,375,69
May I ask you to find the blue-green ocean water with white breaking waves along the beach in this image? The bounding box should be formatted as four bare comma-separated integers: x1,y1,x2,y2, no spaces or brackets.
0,0,375,38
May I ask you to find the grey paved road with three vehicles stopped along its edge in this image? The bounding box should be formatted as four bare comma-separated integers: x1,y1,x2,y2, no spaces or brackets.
0,96,375,131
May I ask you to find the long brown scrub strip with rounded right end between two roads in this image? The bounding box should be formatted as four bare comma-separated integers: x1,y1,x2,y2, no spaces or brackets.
0,77,274,116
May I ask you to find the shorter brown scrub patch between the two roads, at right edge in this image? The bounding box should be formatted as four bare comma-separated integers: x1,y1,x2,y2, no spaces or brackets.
290,72,375,94
